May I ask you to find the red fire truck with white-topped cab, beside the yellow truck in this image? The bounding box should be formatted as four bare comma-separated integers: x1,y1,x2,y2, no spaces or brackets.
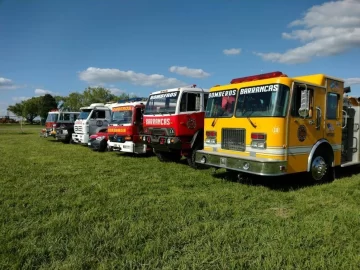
142,85,209,167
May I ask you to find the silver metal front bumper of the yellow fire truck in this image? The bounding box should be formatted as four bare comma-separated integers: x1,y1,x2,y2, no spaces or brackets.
195,150,287,176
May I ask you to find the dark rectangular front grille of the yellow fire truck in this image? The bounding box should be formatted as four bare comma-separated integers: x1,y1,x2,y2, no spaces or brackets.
221,128,246,151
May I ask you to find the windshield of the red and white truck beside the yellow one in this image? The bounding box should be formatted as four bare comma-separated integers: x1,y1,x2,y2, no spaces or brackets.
144,91,179,115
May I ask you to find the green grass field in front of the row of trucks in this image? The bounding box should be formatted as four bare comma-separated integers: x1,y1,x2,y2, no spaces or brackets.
0,125,360,270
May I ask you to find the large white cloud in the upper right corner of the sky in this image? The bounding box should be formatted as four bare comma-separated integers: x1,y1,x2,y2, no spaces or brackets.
255,0,360,64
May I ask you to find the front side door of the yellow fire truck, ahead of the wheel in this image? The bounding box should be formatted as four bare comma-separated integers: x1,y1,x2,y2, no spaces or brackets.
285,83,325,173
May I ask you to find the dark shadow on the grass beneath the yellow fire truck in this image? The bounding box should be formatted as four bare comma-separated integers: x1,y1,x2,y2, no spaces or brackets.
213,166,360,192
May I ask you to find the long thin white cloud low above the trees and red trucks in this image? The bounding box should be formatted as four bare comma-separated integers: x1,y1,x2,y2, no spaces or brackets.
79,67,187,88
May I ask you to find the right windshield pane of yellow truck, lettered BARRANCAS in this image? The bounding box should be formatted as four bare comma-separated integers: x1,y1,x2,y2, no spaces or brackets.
235,84,290,118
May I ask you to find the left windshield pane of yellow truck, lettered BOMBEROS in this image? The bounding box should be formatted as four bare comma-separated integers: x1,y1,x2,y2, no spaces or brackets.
205,88,238,118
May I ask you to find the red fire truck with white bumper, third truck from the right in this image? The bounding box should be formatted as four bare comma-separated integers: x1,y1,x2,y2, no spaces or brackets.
108,98,151,154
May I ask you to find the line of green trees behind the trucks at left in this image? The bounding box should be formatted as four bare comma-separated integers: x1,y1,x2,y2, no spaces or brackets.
8,87,136,124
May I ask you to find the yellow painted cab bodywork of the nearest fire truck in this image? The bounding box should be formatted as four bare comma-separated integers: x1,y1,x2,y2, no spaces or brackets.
204,74,344,176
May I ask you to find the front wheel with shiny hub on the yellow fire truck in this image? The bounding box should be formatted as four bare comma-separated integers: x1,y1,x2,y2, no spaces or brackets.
310,151,335,183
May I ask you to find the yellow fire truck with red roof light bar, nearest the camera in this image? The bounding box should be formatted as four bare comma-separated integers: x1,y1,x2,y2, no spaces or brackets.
196,71,354,181
